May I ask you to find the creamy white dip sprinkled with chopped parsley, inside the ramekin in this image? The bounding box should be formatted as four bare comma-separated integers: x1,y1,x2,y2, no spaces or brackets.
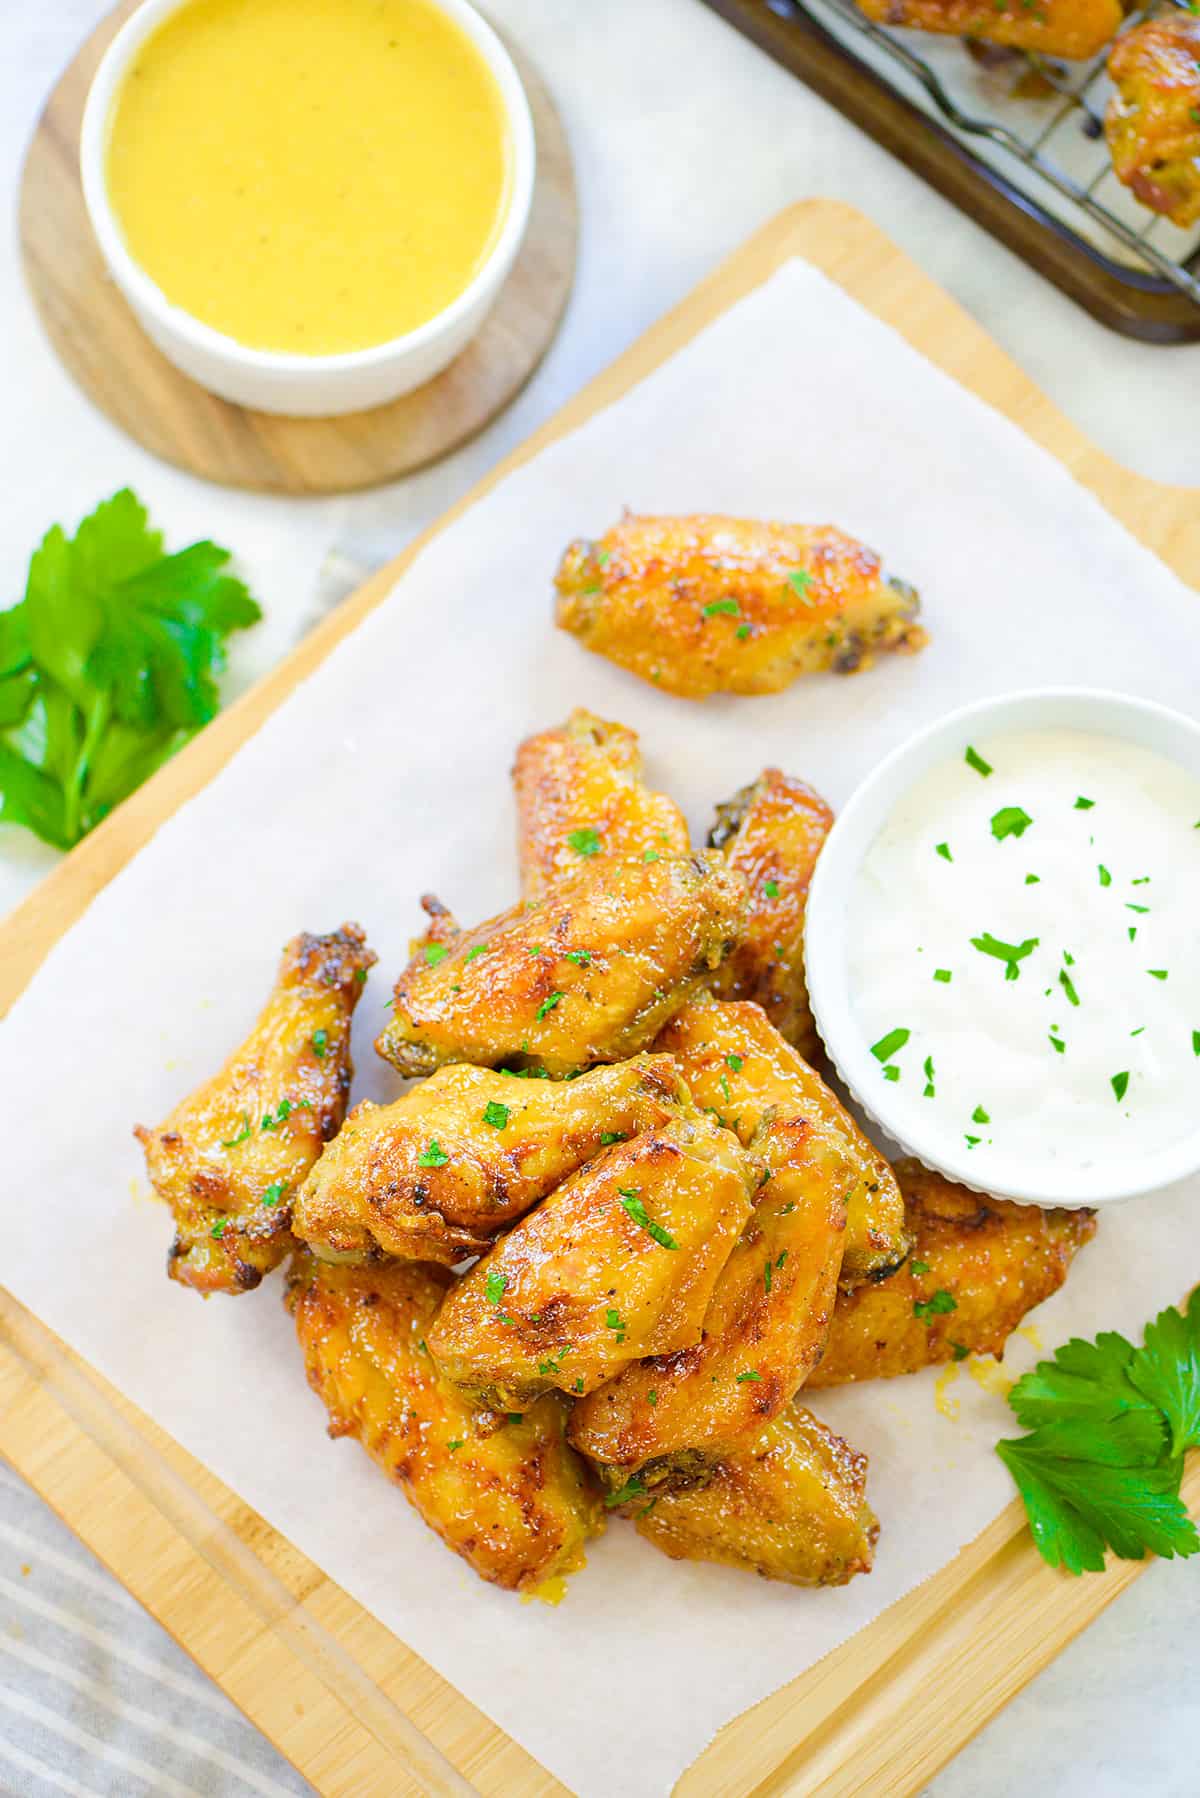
849,730,1200,1185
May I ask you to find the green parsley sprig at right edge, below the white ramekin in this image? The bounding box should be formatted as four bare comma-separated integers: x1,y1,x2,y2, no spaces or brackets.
997,1289,1200,1573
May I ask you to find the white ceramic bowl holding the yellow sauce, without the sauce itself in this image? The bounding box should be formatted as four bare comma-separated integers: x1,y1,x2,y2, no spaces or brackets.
79,0,536,417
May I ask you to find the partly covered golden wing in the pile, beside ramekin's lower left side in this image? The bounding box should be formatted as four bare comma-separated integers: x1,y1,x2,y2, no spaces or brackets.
657,996,909,1287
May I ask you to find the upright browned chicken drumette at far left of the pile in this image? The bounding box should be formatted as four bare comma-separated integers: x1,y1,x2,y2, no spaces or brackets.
135,924,374,1296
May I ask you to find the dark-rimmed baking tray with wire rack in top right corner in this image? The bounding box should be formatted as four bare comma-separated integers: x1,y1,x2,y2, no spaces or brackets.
707,0,1200,342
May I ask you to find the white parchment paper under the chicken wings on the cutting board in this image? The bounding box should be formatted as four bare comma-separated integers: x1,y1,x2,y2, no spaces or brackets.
0,263,1200,1798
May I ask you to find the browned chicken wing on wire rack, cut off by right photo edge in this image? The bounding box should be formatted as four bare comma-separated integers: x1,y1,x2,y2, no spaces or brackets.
1105,11,1200,225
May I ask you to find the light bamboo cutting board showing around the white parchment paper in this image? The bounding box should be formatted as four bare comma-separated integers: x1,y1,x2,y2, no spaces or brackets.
0,201,1200,1798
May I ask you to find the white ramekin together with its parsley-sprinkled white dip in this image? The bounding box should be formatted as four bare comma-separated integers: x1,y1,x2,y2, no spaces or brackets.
806,689,1200,1205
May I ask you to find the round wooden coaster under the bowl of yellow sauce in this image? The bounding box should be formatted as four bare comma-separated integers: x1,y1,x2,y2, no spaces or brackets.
20,0,578,493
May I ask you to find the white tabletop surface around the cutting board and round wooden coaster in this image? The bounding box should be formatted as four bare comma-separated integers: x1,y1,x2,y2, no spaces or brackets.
0,0,1200,1798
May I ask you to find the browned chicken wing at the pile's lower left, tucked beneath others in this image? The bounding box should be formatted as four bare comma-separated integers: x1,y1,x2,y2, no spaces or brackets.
288,1253,604,1598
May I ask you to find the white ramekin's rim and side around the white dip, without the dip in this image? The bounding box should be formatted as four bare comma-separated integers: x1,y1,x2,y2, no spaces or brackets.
804,687,1200,1205
